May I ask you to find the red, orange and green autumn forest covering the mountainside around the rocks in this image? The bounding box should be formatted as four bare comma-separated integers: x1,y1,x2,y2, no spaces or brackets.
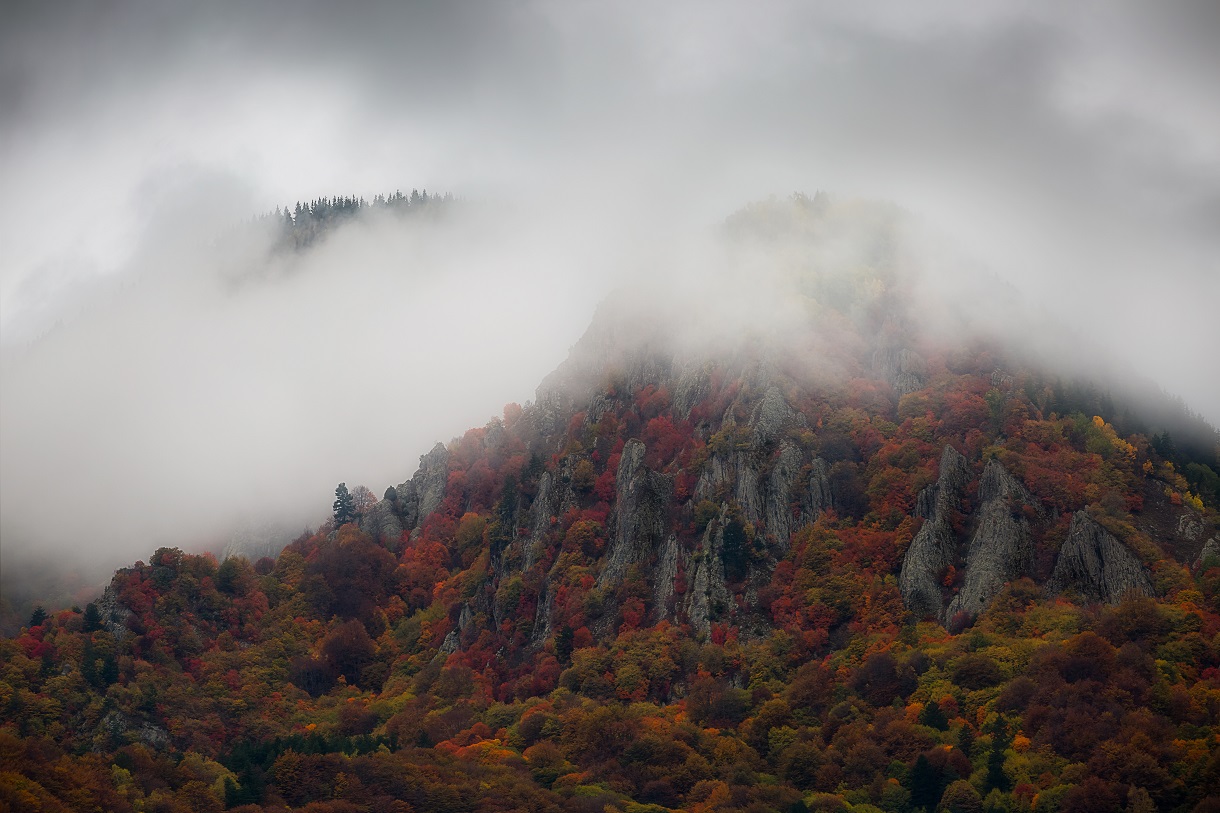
0,192,1220,813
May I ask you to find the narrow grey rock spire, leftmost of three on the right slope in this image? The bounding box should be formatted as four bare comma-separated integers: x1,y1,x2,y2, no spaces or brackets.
898,446,970,619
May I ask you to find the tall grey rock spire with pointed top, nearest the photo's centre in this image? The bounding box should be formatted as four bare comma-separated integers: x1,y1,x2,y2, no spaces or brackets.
598,439,672,586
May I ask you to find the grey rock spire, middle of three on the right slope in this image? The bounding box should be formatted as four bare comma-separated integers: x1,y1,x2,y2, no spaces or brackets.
946,459,1036,620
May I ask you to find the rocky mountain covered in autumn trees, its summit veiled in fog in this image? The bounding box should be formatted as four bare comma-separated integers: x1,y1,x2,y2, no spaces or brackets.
0,194,1220,812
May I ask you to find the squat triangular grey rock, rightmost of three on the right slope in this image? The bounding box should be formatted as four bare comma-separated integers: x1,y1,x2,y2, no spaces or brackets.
1047,511,1154,604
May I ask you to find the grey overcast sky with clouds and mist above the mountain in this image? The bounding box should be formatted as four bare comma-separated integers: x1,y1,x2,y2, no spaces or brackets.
0,0,1220,568
